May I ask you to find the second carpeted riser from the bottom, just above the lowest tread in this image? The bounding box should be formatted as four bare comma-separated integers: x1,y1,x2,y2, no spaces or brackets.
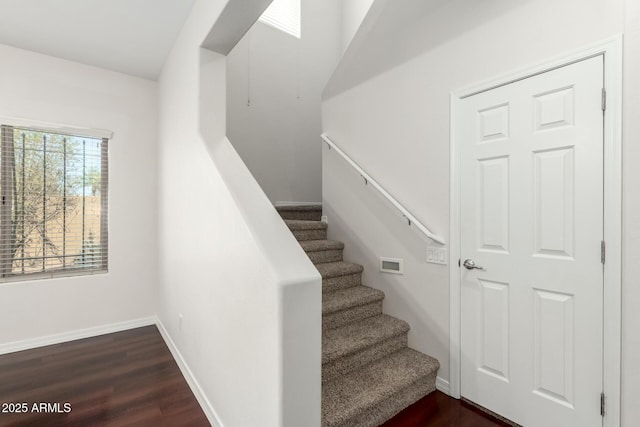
322,332,407,383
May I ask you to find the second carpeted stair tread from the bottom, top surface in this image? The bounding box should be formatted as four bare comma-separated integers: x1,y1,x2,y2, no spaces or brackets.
322,314,409,365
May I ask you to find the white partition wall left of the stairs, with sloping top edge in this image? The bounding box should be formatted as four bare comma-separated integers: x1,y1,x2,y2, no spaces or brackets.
157,0,321,427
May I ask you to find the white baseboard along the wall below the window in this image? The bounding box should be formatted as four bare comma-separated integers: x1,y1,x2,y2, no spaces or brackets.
0,316,157,354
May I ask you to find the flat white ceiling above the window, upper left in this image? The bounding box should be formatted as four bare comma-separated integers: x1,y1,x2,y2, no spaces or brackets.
0,0,195,80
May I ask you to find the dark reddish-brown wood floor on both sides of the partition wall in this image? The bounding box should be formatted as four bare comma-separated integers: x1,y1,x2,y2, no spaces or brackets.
0,326,507,427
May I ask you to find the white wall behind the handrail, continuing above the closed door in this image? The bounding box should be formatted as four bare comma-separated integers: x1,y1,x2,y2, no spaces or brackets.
323,0,624,402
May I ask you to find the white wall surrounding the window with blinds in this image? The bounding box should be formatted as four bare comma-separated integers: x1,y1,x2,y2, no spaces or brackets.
0,45,158,344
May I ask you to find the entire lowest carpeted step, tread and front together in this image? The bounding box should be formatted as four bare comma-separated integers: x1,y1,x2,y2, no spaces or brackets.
322,348,439,427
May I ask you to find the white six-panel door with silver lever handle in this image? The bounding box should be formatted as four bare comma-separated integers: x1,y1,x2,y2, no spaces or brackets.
456,55,604,427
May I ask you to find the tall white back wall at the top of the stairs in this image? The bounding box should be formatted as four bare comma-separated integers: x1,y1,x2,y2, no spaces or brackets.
227,0,341,203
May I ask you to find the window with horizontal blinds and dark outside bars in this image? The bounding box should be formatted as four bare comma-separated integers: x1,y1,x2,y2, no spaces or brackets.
0,125,108,281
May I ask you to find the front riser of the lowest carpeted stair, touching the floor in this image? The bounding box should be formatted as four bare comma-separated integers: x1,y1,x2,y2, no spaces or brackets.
322,372,436,427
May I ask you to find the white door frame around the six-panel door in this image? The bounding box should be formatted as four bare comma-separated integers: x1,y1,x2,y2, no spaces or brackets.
449,35,623,427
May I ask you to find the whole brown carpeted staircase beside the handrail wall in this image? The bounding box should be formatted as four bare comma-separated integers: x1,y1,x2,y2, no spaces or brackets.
276,205,439,427
